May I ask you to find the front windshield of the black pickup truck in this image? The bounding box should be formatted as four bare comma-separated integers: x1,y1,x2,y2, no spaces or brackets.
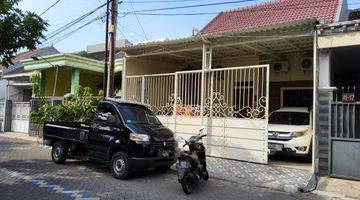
118,104,161,125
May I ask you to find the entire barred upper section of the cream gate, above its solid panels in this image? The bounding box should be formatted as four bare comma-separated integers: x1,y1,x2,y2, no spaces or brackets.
126,65,268,119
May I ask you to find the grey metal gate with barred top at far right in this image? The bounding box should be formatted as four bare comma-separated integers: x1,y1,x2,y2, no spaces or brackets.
329,101,360,180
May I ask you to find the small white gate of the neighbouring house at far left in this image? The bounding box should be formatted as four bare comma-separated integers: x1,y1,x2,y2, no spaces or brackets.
11,102,30,133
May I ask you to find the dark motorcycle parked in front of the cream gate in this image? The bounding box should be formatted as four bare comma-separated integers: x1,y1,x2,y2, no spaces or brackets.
177,127,209,194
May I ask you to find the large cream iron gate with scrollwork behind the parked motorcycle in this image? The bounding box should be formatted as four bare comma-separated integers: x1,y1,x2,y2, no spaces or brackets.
126,65,269,163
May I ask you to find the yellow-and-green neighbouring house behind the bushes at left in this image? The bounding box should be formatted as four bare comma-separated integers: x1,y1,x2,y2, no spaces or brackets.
0,41,127,133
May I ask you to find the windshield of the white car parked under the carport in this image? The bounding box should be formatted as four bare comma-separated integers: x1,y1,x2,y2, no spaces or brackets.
269,112,310,125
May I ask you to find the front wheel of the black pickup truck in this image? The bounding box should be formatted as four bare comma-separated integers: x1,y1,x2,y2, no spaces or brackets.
110,151,131,180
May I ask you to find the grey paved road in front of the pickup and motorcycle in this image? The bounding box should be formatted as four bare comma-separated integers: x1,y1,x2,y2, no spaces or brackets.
0,137,321,200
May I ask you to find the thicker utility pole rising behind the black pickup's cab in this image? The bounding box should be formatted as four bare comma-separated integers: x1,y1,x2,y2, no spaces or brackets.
106,0,118,97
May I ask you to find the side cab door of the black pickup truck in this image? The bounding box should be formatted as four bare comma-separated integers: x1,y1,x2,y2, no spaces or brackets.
88,103,120,160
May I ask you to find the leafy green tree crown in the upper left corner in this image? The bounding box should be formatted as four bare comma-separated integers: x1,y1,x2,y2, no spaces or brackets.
0,0,48,66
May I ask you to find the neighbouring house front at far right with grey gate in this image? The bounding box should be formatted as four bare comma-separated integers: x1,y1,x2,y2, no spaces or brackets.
316,19,360,180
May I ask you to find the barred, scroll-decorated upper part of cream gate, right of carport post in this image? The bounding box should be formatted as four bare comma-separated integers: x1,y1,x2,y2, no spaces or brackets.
204,66,267,119
